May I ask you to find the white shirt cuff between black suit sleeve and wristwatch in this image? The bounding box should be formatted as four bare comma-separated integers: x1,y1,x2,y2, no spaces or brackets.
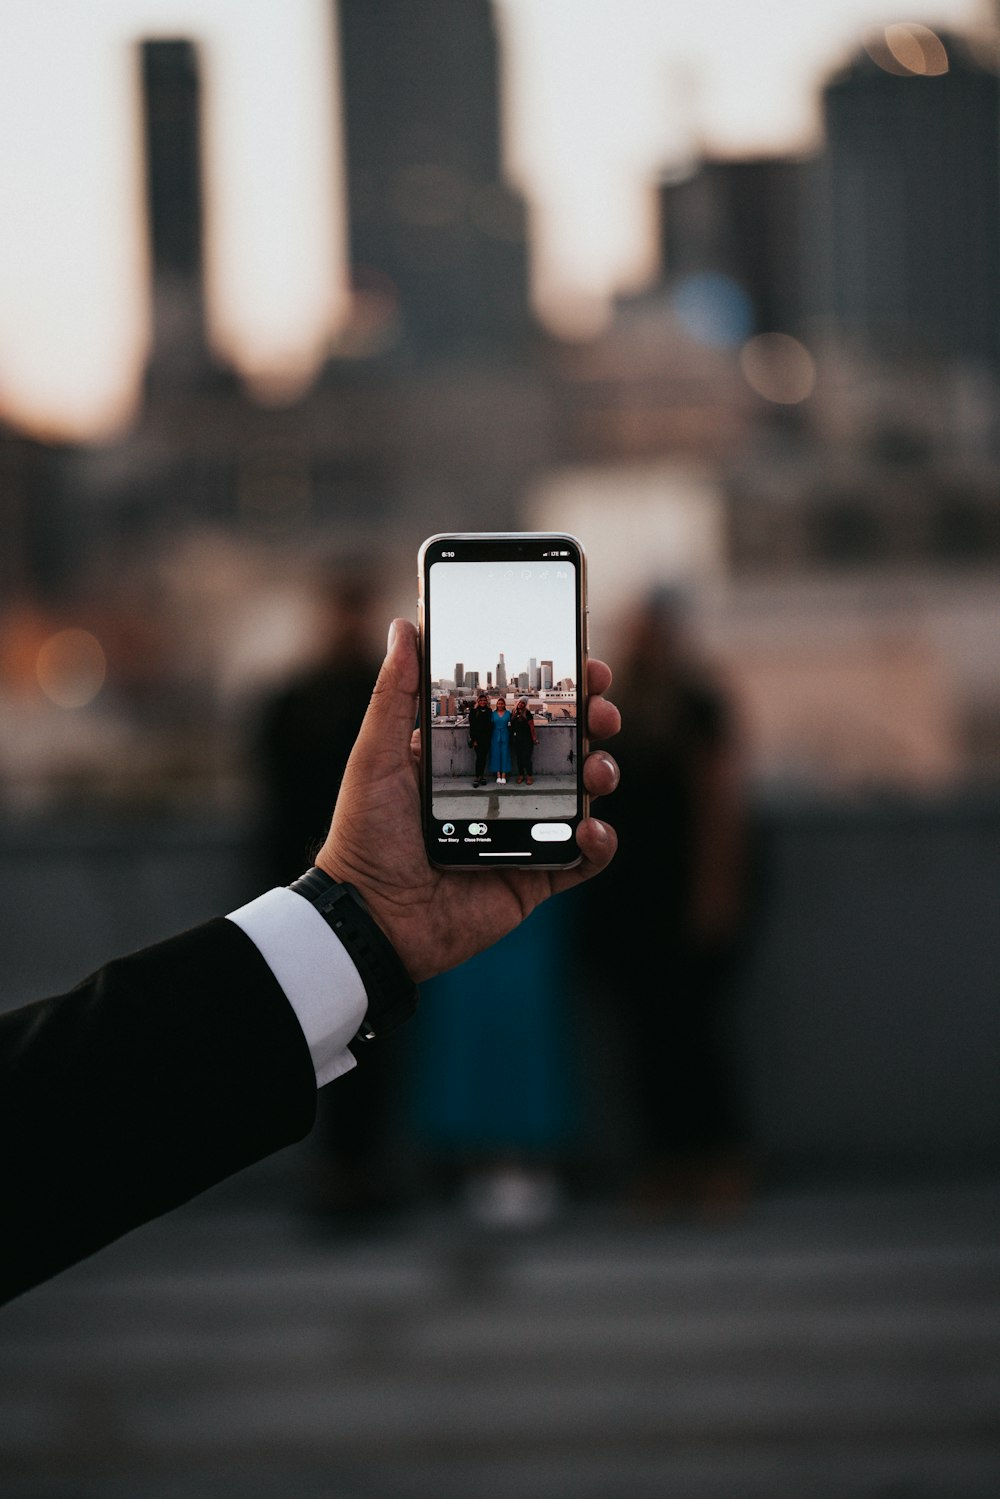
226,887,367,1088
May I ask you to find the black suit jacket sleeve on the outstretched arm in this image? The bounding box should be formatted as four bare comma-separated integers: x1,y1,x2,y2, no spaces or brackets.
0,917,316,1301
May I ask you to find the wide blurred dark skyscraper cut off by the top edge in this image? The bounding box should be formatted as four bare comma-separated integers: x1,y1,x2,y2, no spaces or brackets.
337,0,531,361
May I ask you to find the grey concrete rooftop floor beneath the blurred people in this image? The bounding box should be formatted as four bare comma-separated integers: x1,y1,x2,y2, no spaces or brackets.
0,1153,1000,1499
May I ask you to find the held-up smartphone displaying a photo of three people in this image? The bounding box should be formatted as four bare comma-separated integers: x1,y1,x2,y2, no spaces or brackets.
420,532,588,869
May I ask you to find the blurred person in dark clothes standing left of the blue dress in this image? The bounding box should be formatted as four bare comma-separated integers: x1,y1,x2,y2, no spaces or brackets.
255,559,396,1228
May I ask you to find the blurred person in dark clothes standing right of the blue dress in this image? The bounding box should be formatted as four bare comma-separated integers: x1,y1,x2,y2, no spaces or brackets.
576,588,753,1214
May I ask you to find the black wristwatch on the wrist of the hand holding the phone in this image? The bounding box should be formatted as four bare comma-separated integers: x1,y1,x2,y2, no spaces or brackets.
288,865,418,1040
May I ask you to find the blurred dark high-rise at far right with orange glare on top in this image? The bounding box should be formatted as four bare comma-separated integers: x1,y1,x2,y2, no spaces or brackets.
816,31,1000,367
